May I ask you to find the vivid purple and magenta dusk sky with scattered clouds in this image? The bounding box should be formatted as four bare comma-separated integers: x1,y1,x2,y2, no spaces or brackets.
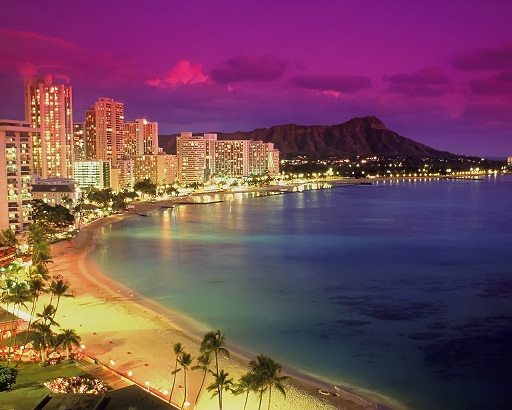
0,0,512,157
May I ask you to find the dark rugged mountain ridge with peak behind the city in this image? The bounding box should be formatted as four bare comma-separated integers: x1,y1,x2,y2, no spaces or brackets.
159,116,452,158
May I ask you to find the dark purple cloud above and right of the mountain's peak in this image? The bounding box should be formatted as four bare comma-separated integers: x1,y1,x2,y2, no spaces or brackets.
384,67,453,98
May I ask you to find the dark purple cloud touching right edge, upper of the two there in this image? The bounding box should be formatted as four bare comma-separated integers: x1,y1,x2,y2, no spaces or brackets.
452,43,512,71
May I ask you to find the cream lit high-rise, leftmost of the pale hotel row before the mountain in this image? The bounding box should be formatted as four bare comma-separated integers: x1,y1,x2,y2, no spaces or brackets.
176,132,206,185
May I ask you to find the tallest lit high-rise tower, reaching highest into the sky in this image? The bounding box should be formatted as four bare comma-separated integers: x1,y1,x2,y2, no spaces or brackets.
25,76,73,178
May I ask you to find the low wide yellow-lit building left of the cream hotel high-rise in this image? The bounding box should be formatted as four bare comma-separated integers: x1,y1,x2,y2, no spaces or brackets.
132,154,177,185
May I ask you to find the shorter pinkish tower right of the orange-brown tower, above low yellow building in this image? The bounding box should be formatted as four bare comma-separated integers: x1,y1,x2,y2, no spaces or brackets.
124,119,158,155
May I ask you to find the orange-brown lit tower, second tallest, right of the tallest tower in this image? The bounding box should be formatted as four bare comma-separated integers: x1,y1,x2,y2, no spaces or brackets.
85,98,124,166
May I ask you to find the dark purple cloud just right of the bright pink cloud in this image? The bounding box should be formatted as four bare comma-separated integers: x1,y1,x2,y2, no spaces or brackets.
210,54,289,84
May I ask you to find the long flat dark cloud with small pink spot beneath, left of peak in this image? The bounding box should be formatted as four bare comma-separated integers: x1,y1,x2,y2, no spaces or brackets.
290,75,372,96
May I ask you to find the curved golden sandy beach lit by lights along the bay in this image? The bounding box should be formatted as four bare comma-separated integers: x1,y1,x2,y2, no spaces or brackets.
45,193,395,410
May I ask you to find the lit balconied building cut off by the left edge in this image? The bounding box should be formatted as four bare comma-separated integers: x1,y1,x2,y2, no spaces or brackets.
0,120,34,233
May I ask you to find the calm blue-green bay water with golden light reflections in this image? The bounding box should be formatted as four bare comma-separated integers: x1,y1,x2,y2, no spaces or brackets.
96,175,512,410
